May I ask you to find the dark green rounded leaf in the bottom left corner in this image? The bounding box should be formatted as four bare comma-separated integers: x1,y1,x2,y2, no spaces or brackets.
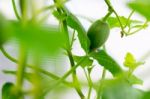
2,82,18,99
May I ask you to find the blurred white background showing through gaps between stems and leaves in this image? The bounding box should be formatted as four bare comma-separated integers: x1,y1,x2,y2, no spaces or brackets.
0,0,150,99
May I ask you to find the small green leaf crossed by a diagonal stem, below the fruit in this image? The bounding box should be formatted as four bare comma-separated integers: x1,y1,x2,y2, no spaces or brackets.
73,56,93,68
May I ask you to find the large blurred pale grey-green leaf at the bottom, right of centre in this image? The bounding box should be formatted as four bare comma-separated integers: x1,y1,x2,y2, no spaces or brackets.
102,79,143,99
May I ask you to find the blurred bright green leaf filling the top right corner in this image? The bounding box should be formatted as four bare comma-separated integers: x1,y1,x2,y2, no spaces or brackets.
128,0,150,20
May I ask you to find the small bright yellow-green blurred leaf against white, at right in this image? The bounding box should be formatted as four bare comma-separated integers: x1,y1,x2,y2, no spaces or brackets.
124,52,144,70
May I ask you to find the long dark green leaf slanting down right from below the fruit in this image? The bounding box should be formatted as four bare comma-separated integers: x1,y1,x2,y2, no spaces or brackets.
91,50,123,76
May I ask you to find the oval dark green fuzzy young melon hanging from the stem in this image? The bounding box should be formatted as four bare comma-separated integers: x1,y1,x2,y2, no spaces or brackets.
87,20,110,50
